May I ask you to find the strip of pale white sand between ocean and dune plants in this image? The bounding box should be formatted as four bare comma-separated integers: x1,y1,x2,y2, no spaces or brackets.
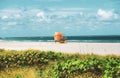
0,41,120,55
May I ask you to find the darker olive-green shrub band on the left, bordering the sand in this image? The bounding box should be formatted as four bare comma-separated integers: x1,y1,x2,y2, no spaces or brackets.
0,50,63,69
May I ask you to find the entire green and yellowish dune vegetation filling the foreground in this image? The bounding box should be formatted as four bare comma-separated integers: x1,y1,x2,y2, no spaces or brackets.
0,49,120,78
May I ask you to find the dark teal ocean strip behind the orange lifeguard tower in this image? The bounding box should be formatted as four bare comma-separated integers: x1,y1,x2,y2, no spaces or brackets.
0,36,120,43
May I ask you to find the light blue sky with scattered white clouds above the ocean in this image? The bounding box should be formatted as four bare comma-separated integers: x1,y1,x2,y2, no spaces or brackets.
0,0,120,37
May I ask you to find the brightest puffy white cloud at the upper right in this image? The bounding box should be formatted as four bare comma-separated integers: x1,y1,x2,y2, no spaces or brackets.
97,9,117,19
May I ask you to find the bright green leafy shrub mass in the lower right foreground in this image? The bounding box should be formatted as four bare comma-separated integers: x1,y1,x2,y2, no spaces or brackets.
54,57,120,78
